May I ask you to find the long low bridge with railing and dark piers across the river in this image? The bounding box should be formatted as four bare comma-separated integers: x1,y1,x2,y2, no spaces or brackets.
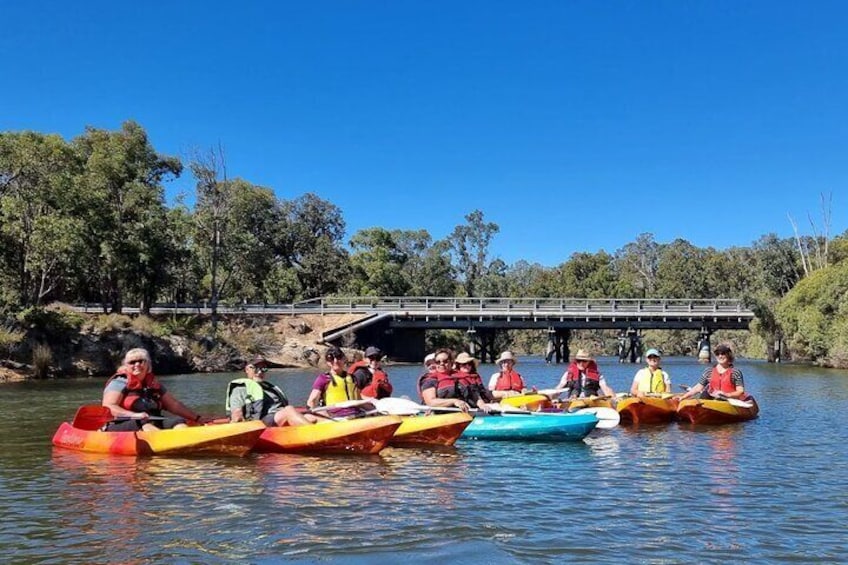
76,296,754,362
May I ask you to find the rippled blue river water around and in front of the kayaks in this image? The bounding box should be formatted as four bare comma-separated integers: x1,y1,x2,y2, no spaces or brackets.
0,358,848,563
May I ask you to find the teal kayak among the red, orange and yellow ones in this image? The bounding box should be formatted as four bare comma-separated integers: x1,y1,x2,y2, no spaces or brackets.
461,412,598,441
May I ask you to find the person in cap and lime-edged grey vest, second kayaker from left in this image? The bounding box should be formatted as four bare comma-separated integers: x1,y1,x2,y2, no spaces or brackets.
225,356,314,427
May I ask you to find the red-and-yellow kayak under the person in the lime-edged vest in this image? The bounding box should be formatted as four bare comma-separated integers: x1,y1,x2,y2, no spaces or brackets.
254,416,401,453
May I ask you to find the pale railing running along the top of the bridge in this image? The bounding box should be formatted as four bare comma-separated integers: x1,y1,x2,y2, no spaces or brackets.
69,296,753,316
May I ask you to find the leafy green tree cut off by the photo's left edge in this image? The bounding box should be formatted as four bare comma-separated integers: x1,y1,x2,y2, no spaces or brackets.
0,132,83,306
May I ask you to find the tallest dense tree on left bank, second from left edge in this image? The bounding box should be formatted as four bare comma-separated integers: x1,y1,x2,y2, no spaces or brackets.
73,121,182,312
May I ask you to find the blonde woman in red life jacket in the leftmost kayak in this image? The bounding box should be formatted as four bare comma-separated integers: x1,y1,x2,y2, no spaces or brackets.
102,347,210,432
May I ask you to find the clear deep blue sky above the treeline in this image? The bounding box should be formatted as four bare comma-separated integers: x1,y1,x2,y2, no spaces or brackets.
0,0,848,266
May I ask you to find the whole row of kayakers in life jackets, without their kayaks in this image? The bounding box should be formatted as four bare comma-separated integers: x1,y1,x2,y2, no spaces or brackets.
97,344,746,431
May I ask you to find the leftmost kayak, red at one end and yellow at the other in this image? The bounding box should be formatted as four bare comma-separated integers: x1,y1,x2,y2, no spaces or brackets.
53,422,265,457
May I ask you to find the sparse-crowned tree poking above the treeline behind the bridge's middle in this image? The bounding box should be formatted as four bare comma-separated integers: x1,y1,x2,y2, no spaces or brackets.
448,210,500,296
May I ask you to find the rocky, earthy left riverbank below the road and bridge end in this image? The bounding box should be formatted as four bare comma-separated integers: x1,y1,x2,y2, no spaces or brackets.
0,308,366,382
